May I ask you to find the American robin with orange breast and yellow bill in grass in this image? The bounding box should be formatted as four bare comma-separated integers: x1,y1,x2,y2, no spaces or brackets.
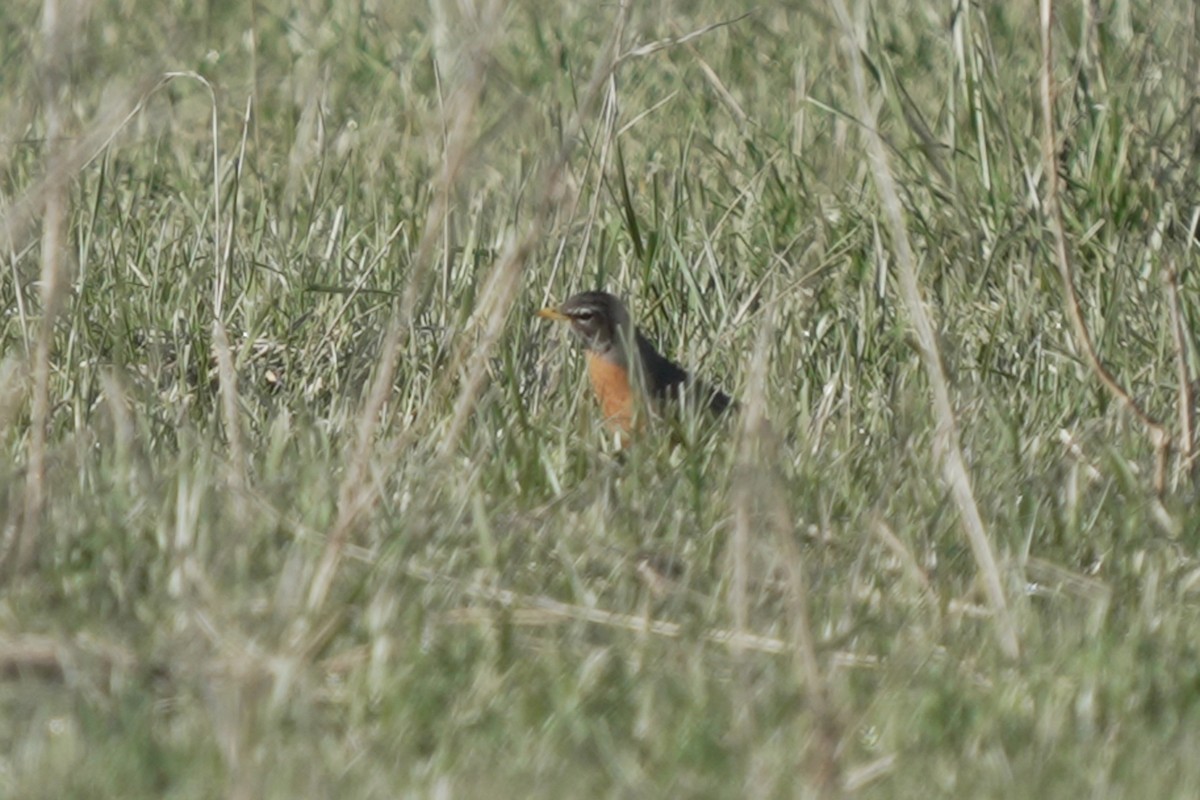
538,291,734,435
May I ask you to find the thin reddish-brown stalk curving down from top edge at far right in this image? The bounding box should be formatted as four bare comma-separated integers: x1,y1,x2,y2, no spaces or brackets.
1039,0,1171,495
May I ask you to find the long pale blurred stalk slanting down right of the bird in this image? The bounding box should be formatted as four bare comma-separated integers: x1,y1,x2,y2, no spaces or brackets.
832,0,1020,658
